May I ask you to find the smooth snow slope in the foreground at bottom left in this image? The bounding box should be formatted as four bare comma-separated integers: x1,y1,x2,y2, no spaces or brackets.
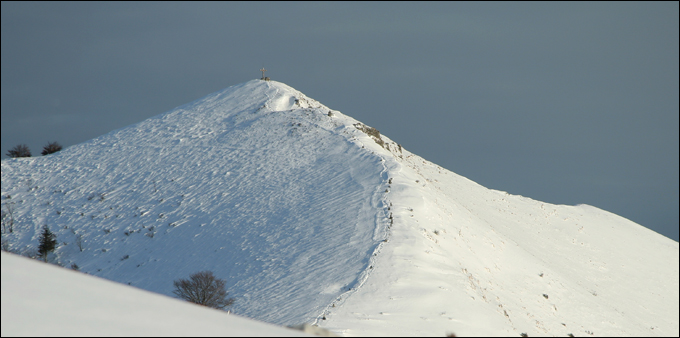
0,252,308,337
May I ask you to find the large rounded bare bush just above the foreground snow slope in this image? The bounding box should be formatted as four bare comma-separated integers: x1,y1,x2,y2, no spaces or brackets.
173,271,234,309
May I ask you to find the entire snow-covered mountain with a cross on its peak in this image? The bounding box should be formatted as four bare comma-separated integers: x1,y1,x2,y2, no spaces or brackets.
2,80,679,336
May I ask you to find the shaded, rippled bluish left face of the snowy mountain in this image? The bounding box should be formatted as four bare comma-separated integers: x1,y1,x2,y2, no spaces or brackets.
2,80,385,324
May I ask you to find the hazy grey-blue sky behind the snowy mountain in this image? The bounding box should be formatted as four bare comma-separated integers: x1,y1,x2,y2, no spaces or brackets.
1,1,680,241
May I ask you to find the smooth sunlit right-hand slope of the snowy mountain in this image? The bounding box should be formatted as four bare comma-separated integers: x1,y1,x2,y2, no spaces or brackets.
319,141,679,336
